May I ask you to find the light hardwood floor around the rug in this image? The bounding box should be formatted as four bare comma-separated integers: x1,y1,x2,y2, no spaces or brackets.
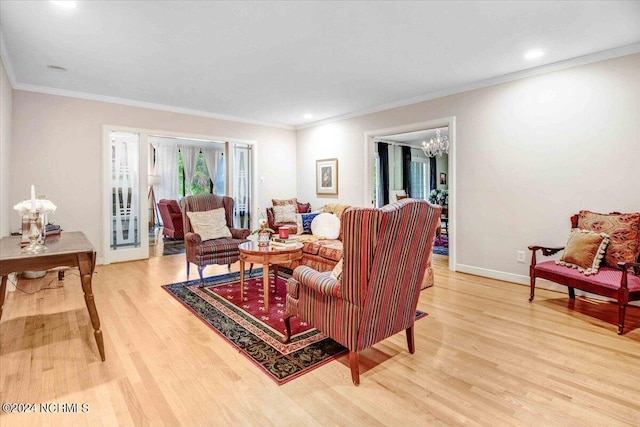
0,255,640,427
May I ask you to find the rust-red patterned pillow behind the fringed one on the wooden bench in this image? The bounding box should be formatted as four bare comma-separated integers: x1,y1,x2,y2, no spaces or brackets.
577,211,640,268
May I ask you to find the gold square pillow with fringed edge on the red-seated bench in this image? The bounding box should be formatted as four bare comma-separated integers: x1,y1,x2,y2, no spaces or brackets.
556,228,609,275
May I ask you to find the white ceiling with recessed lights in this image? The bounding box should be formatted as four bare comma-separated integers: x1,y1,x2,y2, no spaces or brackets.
0,0,640,127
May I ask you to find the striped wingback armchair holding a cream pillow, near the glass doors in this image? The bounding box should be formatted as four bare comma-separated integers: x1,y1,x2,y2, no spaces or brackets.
180,194,251,287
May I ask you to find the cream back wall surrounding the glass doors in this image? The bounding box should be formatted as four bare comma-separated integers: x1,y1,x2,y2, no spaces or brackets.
11,90,296,258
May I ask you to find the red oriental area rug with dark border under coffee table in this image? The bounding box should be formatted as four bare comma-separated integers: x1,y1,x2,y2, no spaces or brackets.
163,271,347,384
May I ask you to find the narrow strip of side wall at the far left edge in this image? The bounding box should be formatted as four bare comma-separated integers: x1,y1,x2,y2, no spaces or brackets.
0,59,11,237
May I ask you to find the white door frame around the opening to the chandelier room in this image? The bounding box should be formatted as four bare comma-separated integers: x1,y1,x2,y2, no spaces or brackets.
363,116,457,271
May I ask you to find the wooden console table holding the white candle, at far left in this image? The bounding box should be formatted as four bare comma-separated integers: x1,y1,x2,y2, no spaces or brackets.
0,231,105,362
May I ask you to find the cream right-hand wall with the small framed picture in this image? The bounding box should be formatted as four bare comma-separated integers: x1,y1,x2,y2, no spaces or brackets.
297,54,640,283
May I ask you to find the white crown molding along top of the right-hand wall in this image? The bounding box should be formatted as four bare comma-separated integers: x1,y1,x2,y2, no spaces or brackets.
295,43,640,130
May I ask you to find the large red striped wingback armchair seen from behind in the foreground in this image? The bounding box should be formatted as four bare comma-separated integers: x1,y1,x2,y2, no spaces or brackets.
283,199,441,385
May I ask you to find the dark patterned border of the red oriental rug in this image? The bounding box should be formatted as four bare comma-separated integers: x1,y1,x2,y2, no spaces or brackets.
162,271,348,385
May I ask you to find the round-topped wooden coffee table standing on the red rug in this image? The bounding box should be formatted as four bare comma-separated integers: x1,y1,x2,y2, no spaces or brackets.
238,241,303,312
